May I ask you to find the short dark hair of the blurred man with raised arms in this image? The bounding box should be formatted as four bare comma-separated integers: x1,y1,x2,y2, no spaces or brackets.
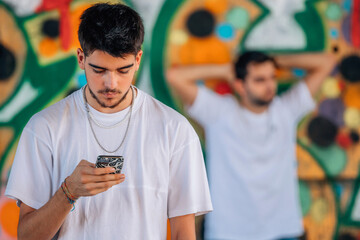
235,51,276,81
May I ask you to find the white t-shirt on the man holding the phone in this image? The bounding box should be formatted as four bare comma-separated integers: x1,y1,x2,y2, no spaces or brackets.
5,86,212,240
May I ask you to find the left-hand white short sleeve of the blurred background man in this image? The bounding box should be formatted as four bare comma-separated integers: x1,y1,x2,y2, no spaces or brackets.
186,86,226,126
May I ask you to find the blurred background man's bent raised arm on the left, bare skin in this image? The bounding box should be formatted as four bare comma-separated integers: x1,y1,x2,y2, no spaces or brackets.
166,63,234,105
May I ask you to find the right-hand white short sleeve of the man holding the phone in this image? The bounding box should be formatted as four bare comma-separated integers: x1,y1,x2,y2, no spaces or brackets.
168,126,213,218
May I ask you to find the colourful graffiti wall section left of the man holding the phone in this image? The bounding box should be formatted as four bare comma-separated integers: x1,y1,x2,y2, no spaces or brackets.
0,0,129,239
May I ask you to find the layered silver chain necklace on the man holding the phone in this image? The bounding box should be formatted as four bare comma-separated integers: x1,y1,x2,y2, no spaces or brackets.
83,85,135,153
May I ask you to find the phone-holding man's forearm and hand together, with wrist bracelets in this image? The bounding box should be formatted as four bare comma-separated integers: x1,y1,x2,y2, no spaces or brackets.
18,160,125,240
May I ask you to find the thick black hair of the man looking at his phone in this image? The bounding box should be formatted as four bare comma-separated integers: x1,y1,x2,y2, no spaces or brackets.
78,3,144,57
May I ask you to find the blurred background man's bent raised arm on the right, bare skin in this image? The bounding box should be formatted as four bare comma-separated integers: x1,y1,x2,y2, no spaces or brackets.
275,53,336,96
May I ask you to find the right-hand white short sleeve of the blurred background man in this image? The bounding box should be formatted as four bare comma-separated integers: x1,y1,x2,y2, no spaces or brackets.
280,81,316,121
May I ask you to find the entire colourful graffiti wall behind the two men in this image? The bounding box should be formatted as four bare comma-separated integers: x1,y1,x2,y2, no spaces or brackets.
0,0,360,240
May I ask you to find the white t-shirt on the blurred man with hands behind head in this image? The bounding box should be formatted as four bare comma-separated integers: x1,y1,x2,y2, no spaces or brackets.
188,82,315,240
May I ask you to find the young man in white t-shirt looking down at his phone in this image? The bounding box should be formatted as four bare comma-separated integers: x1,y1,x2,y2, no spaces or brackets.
5,4,212,240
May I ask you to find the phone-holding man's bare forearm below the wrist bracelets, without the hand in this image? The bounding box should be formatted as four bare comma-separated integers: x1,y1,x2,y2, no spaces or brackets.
18,188,73,240
